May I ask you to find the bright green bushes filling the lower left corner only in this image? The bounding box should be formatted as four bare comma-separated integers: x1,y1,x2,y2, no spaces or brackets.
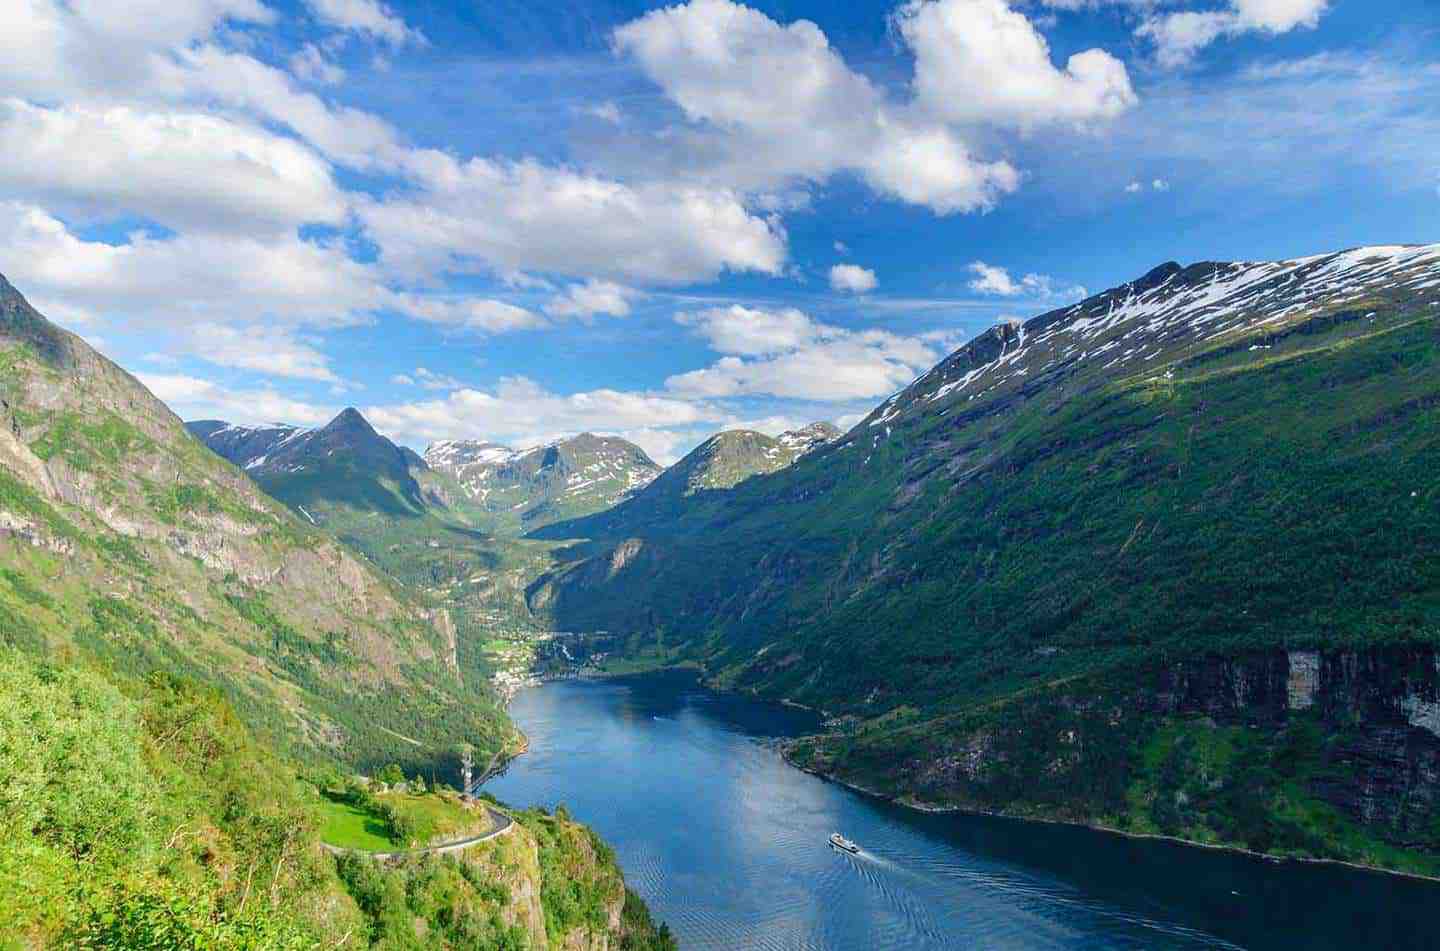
0,651,359,950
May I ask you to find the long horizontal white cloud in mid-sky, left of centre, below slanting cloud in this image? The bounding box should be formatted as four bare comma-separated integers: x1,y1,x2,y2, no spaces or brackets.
360,153,786,284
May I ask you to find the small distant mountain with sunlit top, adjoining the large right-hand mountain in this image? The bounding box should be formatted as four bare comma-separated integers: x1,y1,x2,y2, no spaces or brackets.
534,422,841,539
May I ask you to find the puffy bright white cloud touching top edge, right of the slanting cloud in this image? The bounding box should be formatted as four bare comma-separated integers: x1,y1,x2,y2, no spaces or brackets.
896,0,1138,128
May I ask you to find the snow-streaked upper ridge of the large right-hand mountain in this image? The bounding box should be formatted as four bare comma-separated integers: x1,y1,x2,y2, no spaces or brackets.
845,245,1440,447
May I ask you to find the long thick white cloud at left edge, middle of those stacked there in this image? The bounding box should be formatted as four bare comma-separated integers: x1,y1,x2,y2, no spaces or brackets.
0,98,346,233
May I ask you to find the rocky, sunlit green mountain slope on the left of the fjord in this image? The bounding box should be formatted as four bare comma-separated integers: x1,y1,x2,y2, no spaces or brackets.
0,270,514,765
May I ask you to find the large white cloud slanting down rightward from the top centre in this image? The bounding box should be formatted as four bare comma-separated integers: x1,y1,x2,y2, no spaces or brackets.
615,0,1020,213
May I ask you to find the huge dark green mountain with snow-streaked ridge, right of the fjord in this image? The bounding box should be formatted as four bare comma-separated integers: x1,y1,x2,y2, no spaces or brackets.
530,246,1440,869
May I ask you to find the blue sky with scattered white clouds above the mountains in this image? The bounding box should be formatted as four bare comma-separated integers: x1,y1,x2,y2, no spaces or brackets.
0,0,1440,463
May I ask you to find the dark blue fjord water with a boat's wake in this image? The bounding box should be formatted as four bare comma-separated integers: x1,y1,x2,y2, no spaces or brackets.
485,674,1440,951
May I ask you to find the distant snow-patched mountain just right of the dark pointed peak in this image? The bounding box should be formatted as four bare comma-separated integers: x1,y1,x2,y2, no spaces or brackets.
425,432,661,530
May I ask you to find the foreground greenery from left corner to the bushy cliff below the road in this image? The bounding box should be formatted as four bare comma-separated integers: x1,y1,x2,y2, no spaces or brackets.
0,648,674,951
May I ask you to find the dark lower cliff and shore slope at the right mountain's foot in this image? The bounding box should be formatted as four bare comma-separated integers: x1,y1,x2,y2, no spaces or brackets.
795,644,1440,872
